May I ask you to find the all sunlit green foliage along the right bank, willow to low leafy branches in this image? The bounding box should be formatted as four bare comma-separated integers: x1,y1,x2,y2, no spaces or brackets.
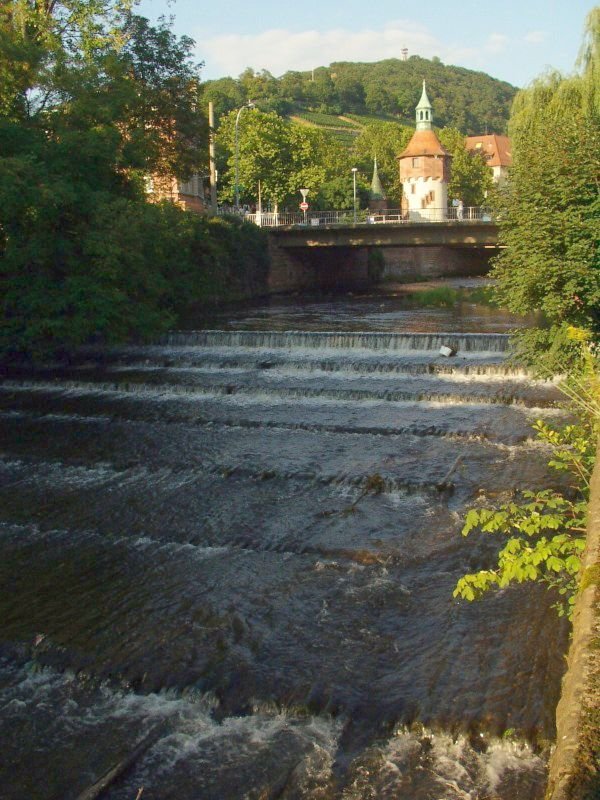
454,7,600,614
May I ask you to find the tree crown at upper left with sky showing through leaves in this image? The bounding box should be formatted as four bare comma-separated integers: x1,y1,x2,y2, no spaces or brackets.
0,0,206,177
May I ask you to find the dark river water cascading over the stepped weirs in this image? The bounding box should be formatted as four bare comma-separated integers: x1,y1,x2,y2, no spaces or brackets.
0,290,566,800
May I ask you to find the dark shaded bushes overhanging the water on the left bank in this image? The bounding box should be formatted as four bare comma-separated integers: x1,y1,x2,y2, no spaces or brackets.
0,138,267,359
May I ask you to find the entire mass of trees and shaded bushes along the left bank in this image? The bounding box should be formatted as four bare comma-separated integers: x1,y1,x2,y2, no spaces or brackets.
0,0,267,358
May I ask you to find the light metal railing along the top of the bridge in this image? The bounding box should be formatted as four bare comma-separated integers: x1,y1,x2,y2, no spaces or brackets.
244,206,493,228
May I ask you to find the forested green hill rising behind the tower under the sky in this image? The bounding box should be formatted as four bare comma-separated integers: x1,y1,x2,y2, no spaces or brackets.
203,56,517,136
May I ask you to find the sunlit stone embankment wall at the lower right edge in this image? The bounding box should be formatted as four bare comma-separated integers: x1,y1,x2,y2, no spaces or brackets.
546,447,600,800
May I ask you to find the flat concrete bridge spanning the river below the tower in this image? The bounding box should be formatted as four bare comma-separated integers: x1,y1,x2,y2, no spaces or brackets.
268,219,498,292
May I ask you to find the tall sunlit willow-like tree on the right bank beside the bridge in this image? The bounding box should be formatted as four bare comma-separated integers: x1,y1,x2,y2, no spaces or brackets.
493,8,600,360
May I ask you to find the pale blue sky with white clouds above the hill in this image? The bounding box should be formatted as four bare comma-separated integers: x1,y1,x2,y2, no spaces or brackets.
138,0,595,87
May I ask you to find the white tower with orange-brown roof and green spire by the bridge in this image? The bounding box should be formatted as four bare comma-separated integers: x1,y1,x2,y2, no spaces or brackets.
398,81,452,222
